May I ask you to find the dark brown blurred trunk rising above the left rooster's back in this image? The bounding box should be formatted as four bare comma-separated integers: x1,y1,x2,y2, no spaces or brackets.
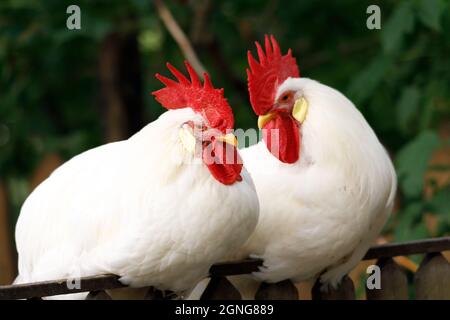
99,17,143,142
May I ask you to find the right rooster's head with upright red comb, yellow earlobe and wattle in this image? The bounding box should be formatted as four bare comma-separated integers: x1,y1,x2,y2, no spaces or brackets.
247,35,308,163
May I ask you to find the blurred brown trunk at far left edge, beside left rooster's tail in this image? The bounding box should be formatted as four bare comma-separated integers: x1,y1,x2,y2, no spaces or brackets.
0,181,16,285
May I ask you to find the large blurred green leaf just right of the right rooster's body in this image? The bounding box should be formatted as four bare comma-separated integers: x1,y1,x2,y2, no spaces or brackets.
395,131,440,197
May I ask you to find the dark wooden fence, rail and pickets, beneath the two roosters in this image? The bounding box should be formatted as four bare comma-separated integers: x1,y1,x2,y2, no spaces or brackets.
0,237,450,300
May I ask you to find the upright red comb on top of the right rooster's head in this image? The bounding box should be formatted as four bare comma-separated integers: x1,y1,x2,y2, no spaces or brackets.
247,35,300,115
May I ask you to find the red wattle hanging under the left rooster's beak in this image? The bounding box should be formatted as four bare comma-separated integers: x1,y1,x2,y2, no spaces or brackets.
202,140,243,185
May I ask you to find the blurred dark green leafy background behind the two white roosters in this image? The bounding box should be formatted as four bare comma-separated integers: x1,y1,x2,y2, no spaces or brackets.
0,0,450,298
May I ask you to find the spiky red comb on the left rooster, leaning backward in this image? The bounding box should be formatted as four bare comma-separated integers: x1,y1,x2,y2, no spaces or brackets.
152,61,234,132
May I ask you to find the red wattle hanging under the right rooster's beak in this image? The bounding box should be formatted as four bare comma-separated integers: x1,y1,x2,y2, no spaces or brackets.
263,112,300,163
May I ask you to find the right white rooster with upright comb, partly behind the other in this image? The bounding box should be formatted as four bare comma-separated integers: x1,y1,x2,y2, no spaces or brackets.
227,36,396,298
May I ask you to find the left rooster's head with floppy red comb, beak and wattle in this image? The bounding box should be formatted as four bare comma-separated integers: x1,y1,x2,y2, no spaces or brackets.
152,61,242,185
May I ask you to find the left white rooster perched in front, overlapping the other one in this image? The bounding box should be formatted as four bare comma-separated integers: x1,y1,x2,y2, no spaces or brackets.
15,63,259,298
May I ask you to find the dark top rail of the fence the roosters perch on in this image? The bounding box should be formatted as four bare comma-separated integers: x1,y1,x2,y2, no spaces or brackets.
0,237,450,300
